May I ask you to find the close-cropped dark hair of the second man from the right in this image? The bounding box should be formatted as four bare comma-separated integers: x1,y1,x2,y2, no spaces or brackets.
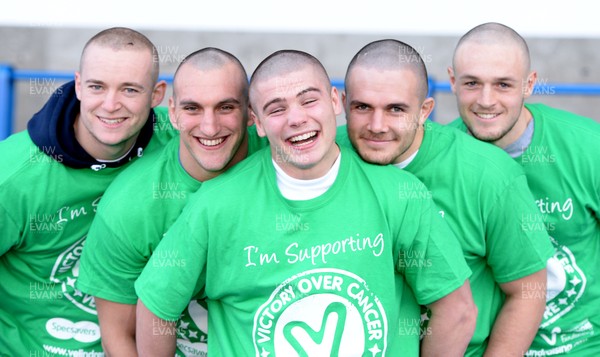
345,39,429,100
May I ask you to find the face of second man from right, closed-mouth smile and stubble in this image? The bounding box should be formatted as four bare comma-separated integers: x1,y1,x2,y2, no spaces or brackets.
343,66,433,165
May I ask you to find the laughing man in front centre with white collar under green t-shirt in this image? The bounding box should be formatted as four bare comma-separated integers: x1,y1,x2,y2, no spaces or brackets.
136,50,476,356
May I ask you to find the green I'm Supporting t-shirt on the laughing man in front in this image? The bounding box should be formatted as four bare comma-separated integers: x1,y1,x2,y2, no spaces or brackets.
135,148,470,356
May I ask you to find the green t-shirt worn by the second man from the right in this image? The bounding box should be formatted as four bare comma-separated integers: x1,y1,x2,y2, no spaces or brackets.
338,121,553,356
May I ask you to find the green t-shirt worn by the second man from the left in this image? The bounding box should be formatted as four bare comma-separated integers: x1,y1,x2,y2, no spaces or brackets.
77,126,268,356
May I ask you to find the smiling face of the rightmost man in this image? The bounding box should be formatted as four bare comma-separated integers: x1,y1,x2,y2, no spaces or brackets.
448,41,537,148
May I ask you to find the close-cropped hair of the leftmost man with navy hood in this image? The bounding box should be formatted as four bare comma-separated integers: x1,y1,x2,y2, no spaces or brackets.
79,27,159,83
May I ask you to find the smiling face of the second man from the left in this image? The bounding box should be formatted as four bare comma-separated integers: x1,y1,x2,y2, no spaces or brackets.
169,63,248,181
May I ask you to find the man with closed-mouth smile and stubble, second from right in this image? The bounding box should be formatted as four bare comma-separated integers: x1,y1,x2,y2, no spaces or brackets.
338,39,552,356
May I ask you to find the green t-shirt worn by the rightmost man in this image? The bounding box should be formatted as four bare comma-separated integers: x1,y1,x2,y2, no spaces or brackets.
451,104,600,356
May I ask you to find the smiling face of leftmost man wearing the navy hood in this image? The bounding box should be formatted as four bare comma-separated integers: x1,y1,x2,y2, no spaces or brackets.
74,44,166,160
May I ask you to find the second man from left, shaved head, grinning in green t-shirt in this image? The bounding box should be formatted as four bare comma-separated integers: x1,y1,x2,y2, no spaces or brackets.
77,48,267,356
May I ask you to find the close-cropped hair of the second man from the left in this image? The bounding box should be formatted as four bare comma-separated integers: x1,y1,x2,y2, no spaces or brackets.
173,47,248,96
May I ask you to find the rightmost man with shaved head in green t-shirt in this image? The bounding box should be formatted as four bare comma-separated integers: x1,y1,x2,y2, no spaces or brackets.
448,23,600,356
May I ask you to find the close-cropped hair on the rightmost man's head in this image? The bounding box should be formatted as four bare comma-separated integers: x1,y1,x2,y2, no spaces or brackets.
452,22,531,72
